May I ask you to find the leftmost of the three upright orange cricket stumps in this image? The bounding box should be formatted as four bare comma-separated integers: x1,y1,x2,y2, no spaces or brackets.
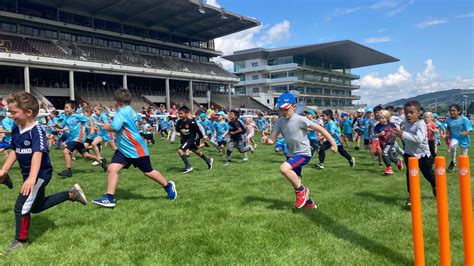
408,157,425,266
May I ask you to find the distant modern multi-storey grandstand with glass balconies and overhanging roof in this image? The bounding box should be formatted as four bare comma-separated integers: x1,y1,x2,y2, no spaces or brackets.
223,40,399,109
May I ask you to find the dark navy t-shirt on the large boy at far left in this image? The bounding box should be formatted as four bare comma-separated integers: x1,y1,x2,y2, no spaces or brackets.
11,124,53,181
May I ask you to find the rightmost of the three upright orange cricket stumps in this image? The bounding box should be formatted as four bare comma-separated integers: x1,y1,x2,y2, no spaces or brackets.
458,155,474,265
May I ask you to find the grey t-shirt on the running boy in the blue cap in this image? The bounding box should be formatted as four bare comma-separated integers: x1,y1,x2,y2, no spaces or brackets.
273,114,311,156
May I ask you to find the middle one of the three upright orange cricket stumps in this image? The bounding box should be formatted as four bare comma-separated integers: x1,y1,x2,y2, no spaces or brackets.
435,156,451,266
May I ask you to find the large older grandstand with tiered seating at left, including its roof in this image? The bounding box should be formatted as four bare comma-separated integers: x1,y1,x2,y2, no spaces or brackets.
0,0,270,109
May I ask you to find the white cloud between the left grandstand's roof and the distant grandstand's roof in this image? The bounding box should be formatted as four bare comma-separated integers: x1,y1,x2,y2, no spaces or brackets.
215,20,291,69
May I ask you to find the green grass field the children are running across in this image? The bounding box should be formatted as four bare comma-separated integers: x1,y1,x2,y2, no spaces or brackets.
0,134,473,265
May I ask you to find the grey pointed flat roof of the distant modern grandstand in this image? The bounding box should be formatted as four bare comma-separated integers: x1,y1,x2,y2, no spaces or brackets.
222,40,400,68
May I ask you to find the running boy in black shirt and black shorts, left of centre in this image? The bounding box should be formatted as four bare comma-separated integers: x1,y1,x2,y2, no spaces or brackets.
176,106,214,174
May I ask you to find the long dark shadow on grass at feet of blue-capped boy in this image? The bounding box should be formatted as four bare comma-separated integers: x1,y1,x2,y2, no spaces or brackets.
244,197,413,265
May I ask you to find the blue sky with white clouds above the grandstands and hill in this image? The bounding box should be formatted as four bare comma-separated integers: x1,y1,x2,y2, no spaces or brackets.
207,0,474,104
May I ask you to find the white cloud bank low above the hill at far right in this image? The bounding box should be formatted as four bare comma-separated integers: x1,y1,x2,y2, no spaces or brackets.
354,59,474,106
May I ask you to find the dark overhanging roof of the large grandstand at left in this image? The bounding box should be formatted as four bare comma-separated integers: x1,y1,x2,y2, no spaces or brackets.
25,0,260,40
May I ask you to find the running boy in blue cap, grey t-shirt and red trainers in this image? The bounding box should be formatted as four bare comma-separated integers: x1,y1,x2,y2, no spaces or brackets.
262,93,337,209
